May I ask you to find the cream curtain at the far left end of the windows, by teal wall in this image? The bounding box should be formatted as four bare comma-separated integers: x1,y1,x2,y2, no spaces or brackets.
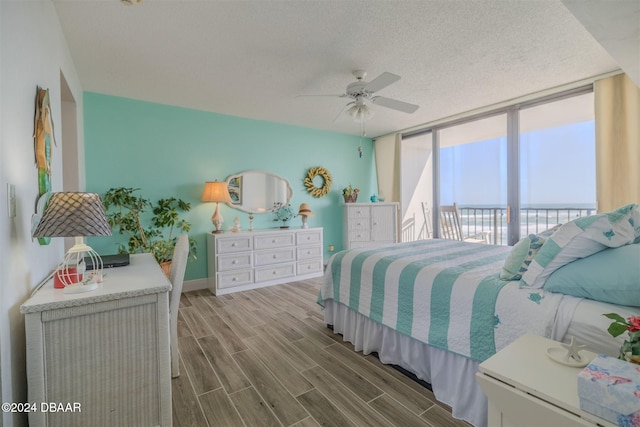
374,133,402,202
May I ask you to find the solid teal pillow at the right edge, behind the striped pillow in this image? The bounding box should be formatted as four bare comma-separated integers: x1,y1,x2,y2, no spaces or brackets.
544,244,640,307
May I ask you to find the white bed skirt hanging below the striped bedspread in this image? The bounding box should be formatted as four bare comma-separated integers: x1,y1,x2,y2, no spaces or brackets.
324,300,487,427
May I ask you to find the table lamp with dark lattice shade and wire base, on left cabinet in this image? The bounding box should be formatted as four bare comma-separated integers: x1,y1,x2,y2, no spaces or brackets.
33,192,111,293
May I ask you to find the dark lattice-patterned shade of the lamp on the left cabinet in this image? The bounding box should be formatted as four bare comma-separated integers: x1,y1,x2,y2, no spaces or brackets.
33,192,111,237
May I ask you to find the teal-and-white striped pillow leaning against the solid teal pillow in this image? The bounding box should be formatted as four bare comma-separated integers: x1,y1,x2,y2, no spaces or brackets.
520,204,640,288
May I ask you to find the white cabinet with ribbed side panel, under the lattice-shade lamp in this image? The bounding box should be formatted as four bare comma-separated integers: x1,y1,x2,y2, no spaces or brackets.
20,254,172,427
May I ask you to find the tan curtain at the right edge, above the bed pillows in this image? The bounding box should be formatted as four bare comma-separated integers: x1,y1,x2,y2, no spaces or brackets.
594,74,640,212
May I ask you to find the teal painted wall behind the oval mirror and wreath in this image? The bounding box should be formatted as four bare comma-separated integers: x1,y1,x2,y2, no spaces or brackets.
83,92,377,280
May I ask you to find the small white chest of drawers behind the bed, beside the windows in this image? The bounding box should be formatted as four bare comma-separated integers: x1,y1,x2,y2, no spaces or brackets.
342,203,398,249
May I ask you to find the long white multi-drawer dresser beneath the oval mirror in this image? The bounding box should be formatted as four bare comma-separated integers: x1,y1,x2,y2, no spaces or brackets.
207,228,323,295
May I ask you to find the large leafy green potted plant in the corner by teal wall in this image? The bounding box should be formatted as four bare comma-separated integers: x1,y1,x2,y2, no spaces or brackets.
102,187,196,274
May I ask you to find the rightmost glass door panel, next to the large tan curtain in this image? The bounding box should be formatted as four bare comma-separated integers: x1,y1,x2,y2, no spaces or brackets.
520,92,596,236
